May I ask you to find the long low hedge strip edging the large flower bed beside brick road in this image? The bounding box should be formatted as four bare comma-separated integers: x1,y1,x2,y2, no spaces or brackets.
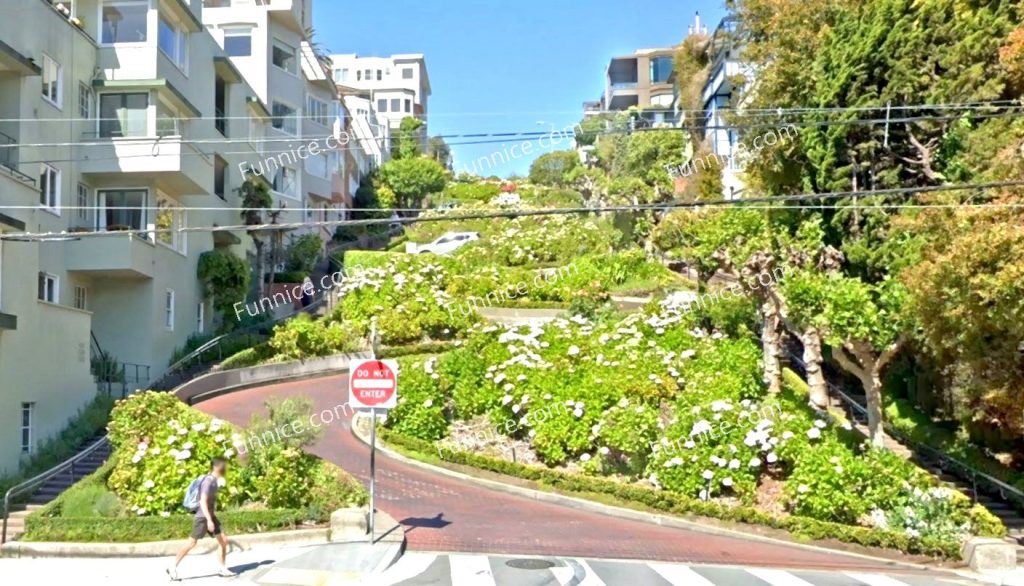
380,428,961,559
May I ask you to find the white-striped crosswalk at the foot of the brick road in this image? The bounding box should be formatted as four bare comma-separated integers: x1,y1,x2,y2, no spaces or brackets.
372,552,974,586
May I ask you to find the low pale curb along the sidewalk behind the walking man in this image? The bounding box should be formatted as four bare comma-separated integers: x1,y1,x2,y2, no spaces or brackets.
0,528,331,557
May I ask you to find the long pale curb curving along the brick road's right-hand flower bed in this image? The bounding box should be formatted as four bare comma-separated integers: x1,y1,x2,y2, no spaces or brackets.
351,413,953,573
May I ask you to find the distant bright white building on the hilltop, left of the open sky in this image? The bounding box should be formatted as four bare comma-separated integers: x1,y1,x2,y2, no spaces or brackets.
331,53,430,145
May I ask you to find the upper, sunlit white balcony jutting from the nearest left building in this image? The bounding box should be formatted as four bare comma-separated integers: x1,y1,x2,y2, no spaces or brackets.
79,135,213,194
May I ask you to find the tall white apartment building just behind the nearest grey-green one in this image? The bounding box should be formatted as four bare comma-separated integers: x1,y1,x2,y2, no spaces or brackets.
203,0,350,244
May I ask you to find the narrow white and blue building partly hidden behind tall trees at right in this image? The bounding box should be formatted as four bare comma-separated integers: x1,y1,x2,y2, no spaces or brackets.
701,16,753,199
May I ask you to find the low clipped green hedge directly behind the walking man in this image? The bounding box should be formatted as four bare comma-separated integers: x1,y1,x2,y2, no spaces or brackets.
22,509,319,543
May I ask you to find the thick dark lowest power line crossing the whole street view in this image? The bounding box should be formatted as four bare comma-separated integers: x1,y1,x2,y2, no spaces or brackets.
0,180,1024,242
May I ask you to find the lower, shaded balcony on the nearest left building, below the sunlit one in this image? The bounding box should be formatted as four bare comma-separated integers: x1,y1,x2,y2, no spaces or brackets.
65,234,158,279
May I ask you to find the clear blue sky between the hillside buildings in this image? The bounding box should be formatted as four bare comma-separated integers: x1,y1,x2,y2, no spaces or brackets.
313,0,725,177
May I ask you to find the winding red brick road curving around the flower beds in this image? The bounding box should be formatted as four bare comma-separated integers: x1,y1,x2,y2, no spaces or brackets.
198,375,925,572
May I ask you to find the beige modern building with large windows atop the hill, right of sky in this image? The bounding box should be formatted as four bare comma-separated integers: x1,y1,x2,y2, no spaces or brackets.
584,48,679,125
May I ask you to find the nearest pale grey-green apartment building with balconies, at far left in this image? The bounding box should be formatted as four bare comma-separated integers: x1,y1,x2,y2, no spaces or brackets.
0,0,271,474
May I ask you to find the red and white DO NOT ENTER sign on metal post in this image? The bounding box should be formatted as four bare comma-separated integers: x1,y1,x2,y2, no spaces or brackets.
348,320,398,543
